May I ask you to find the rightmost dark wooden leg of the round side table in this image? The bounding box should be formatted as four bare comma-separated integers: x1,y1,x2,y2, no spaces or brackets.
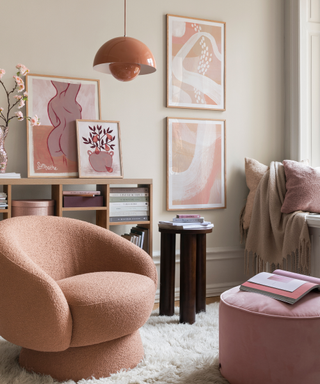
196,233,207,313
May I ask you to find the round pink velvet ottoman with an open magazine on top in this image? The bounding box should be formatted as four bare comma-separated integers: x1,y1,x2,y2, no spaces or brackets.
219,287,320,384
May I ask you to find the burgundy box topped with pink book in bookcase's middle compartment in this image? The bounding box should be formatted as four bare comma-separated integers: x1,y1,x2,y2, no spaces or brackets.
62,191,103,207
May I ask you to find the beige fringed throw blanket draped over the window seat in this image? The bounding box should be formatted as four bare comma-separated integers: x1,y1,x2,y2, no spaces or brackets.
240,162,310,274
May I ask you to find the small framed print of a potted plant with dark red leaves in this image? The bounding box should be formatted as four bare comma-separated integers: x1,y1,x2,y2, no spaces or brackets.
77,120,123,178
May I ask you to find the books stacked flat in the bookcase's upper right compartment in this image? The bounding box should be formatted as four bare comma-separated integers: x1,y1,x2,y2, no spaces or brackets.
109,187,150,222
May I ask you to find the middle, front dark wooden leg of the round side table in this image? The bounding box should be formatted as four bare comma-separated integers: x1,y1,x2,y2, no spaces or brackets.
180,233,197,324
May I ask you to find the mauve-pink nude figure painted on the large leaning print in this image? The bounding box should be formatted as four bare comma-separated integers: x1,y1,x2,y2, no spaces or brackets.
48,81,82,161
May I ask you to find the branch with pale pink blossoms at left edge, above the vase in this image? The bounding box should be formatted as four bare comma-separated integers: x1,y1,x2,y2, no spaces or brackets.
0,64,40,129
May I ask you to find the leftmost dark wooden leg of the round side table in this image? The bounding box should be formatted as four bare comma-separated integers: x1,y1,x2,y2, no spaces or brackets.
159,233,176,316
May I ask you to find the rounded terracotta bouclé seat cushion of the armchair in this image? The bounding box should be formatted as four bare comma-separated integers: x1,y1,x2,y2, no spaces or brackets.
57,272,155,347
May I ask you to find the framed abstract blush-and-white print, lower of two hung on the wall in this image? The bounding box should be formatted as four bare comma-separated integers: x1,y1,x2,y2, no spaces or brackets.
167,118,226,211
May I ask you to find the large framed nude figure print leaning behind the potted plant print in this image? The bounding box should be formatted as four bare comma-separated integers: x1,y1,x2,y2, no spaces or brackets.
26,74,100,177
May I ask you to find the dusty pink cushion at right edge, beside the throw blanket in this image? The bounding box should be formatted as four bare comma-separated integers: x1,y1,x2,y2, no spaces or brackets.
281,160,320,213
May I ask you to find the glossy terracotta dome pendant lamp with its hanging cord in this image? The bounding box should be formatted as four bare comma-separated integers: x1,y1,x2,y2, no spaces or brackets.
93,0,156,81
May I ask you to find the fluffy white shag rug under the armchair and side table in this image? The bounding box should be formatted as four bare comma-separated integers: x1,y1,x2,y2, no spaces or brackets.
0,303,228,384
